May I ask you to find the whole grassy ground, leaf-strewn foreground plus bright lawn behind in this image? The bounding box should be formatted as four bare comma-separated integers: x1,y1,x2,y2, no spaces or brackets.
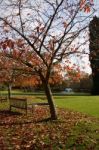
0,95,99,150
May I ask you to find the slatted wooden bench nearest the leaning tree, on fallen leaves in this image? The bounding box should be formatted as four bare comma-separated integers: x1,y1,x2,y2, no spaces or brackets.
9,97,27,114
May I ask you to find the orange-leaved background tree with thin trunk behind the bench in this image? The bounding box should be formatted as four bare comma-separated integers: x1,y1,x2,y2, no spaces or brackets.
0,53,37,99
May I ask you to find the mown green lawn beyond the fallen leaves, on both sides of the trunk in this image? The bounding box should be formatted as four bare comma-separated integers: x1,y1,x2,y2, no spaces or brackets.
0,93,99,118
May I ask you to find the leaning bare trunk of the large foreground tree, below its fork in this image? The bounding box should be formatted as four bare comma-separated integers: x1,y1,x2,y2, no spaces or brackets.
44,82,57,120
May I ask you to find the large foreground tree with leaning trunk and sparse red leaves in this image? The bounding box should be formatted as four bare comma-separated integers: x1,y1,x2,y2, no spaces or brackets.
0,0,93,119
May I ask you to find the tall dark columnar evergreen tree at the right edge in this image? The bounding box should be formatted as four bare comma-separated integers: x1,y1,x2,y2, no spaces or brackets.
89,16,99,95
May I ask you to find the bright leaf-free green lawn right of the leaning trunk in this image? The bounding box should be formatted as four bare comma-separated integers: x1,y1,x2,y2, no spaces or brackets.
54,96,99,118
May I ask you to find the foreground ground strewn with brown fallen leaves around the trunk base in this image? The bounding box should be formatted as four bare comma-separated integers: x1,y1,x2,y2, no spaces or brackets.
0,108,99,150
